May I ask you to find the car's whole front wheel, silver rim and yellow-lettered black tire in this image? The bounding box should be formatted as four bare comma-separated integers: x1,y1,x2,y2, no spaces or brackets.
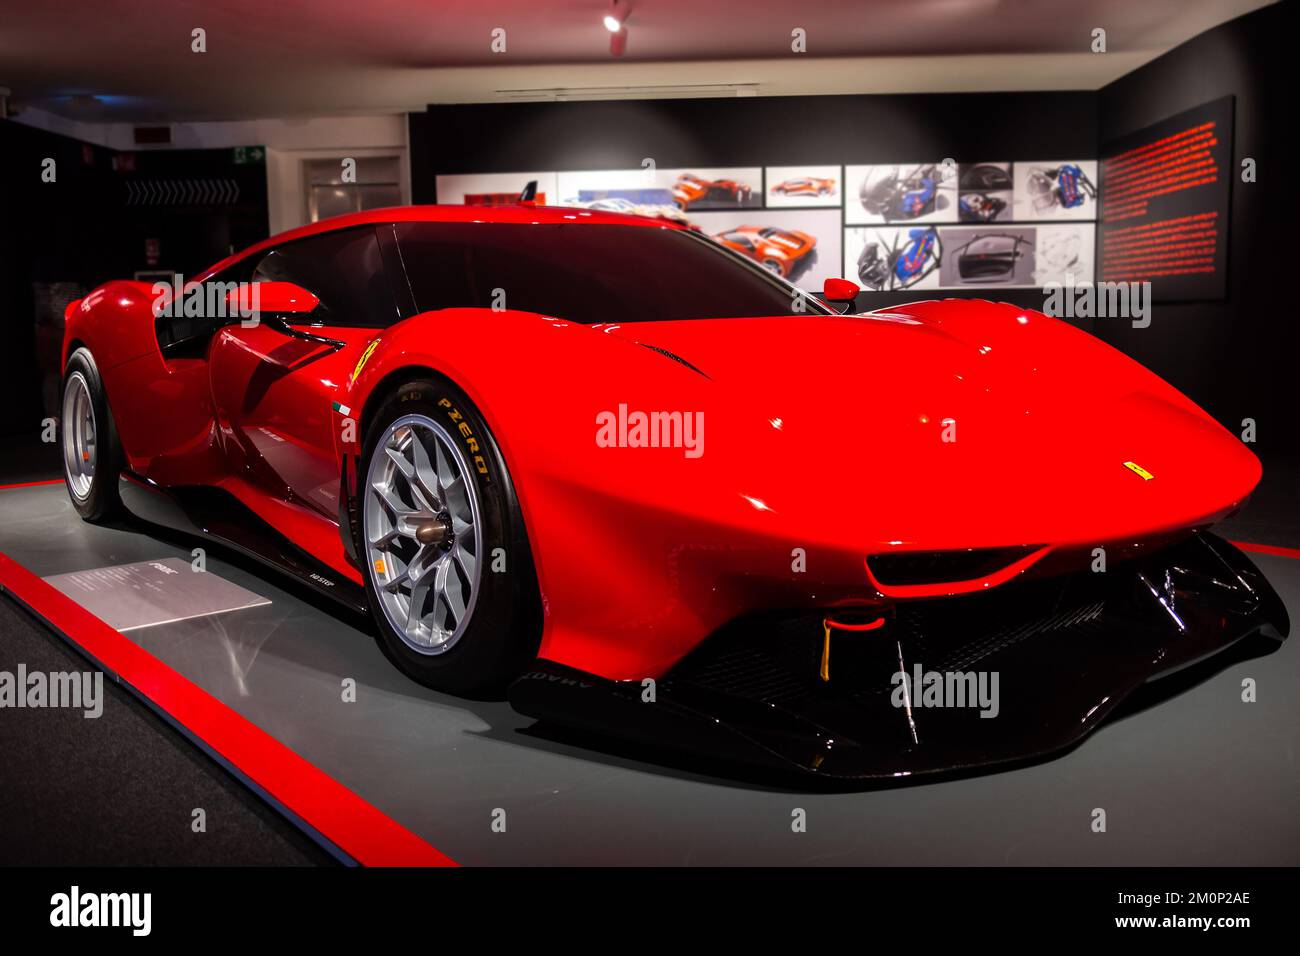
356,376,541,697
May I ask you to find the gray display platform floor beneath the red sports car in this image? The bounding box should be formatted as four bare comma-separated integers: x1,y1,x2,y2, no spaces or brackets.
0,485,1300,866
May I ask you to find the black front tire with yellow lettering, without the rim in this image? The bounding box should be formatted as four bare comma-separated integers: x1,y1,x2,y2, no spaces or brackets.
356,376,542,698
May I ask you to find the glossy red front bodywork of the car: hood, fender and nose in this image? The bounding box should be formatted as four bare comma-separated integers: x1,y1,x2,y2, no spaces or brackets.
348,300,1260,679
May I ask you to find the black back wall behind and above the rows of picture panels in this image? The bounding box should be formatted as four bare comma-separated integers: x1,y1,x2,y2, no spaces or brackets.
411,92,1097,308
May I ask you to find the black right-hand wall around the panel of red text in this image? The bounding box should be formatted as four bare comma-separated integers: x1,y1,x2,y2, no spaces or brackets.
1095,0,1300,455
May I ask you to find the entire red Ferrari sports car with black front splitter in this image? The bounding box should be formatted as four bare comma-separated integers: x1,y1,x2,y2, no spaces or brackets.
61,206,1287,778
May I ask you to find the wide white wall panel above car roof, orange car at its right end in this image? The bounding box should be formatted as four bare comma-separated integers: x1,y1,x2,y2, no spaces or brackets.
553,166,763,213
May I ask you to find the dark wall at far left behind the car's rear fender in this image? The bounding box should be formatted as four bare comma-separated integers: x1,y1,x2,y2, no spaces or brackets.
0,120,268,440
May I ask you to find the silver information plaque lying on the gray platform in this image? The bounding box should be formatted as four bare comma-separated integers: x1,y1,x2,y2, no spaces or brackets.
46,558,270,632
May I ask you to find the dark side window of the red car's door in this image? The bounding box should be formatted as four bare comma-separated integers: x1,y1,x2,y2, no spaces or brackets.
252,225,399,329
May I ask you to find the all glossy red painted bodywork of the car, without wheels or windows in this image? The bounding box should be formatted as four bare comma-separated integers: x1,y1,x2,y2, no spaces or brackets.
68,207,1260,679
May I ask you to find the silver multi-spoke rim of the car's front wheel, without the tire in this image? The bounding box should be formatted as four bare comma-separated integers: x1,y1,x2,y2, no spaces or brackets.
363,415,482,654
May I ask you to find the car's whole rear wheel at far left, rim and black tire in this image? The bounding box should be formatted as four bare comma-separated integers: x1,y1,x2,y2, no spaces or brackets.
59,349,125,522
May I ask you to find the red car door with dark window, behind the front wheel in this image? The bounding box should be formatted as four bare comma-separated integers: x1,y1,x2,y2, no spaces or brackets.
209,225,399,520
